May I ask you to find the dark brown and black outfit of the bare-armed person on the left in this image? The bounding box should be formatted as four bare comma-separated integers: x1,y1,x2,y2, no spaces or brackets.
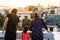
4,13,19,40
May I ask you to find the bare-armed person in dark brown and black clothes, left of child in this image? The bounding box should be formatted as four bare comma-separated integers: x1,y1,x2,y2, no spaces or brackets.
2,9,19,40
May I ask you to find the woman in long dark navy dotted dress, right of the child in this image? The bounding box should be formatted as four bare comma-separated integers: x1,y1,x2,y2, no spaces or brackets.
30,13,47,40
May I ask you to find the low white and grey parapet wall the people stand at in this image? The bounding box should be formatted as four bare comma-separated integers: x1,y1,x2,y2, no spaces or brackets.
0,31,60,40
